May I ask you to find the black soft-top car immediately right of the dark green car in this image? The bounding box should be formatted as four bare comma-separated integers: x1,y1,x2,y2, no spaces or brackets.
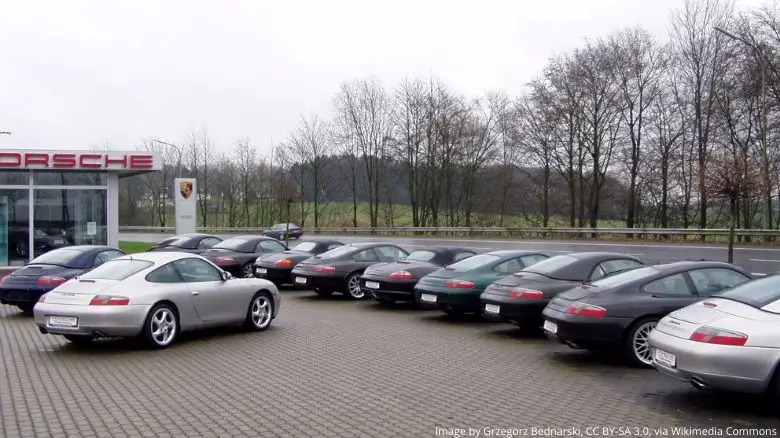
480,252,644,329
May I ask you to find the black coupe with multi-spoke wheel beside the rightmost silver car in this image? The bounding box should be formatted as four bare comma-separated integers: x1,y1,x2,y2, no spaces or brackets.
543,261,751,367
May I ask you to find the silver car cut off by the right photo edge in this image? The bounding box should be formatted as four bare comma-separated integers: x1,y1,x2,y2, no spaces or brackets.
649,275,780,395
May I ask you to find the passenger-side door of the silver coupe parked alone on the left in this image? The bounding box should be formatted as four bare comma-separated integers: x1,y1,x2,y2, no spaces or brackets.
173,257,238,325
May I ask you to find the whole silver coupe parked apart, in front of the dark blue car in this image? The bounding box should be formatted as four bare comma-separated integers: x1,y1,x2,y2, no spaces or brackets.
33,252,281,348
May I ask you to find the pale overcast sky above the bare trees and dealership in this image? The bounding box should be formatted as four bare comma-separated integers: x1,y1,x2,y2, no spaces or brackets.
0,0,762,157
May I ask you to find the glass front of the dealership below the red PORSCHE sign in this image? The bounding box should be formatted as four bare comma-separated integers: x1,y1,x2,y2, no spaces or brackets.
0,170,108,267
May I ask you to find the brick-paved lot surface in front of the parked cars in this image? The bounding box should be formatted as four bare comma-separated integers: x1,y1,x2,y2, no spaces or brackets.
0,291,780,438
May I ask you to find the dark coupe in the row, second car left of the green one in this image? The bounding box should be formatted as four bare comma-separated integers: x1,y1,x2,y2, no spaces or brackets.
292,242,409,300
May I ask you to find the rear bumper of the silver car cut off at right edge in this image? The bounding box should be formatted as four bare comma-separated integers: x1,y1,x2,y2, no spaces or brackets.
649,330,780,394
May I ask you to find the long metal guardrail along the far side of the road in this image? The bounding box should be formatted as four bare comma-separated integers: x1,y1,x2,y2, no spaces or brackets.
119,226,780,239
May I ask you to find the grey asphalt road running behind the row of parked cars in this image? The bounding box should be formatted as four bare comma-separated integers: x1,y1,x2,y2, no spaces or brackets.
119,233,780,275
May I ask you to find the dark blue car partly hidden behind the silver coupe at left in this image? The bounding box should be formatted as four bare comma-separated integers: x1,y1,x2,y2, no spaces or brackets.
0,245,125,315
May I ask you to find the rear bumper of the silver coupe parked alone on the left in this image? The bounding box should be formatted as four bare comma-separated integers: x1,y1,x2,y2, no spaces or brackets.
33,303,151,337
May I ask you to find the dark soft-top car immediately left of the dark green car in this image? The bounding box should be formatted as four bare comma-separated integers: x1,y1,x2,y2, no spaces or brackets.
360,247,476,304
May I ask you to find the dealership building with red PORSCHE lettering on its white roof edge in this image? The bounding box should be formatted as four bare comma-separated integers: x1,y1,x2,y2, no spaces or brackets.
0,149,163,267
